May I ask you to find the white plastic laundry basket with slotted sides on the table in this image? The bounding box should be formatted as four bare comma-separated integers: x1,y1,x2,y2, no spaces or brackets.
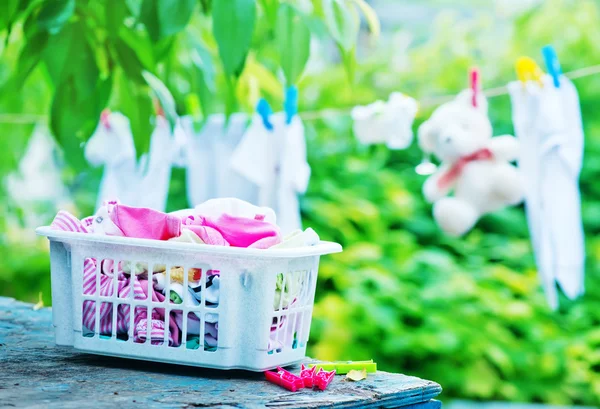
36,227,342,371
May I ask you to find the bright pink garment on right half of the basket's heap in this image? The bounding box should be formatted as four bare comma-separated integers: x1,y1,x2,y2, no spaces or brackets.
201,213,281,248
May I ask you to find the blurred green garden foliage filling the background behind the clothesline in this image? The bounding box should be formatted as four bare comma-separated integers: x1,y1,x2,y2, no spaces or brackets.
0,0,600,405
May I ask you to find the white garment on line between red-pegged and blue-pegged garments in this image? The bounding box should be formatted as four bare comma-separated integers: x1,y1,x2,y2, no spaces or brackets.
182,113,258,207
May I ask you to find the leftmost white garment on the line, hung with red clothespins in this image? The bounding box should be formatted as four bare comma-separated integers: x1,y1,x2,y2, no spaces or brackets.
85,112,176,211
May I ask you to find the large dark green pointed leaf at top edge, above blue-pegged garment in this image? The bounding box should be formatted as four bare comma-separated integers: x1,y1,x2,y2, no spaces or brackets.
212,0,256,77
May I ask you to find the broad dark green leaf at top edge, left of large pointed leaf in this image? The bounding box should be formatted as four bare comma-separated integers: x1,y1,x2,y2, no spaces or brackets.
140,0,196,42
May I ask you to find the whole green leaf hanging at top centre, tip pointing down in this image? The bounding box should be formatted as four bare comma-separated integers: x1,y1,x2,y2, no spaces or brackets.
275,4,310,86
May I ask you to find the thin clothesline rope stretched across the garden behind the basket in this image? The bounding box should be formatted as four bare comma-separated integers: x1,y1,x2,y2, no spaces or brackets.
0,64,600,124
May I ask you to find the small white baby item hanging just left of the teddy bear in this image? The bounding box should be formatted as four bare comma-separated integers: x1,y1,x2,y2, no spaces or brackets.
351,92,418,149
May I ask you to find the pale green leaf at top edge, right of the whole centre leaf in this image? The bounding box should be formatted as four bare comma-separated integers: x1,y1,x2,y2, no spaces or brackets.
322,0,359,51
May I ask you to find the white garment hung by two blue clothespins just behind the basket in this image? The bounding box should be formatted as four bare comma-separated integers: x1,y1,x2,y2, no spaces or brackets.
231,112,310,234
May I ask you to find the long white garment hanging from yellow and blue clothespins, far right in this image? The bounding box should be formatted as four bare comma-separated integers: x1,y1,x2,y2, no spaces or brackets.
508,76,585,309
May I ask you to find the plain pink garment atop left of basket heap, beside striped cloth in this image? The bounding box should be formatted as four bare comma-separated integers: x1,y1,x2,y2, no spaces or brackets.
110,204,181,240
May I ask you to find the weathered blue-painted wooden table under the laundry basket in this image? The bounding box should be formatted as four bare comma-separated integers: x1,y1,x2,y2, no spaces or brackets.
0,297,441,409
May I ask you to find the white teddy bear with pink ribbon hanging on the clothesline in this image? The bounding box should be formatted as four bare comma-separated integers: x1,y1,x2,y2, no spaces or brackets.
418,90,524,236
